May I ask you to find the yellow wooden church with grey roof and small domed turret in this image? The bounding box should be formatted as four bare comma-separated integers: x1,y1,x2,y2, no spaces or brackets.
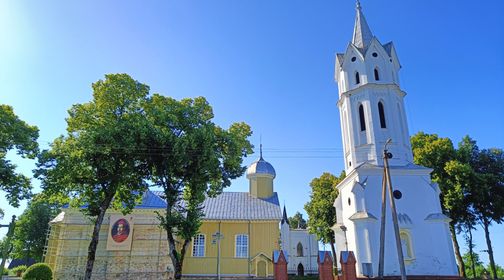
45,153,282,279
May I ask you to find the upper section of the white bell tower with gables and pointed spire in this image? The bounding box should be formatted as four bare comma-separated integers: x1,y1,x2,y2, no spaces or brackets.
335,1,413,174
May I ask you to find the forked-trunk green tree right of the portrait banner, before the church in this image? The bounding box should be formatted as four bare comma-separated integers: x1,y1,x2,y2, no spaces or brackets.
146,95,252,279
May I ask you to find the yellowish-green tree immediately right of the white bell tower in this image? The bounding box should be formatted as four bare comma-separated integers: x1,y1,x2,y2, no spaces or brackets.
411,132,467,277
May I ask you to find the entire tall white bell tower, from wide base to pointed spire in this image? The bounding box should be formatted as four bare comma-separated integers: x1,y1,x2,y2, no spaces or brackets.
333,4,457,276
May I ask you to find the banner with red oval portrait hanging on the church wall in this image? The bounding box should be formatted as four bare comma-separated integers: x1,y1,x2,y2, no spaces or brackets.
107,215,133,251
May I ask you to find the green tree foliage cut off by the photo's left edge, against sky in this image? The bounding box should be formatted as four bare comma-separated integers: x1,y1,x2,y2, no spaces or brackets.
0,105,39,207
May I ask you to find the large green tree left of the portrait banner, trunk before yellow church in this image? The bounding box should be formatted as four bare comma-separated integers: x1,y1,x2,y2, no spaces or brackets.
36,74,149,279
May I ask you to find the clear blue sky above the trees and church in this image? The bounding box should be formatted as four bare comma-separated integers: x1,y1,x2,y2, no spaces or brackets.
0,0,504,265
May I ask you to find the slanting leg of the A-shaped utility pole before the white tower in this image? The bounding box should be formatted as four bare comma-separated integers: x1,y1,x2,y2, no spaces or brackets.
380,139,407,280
